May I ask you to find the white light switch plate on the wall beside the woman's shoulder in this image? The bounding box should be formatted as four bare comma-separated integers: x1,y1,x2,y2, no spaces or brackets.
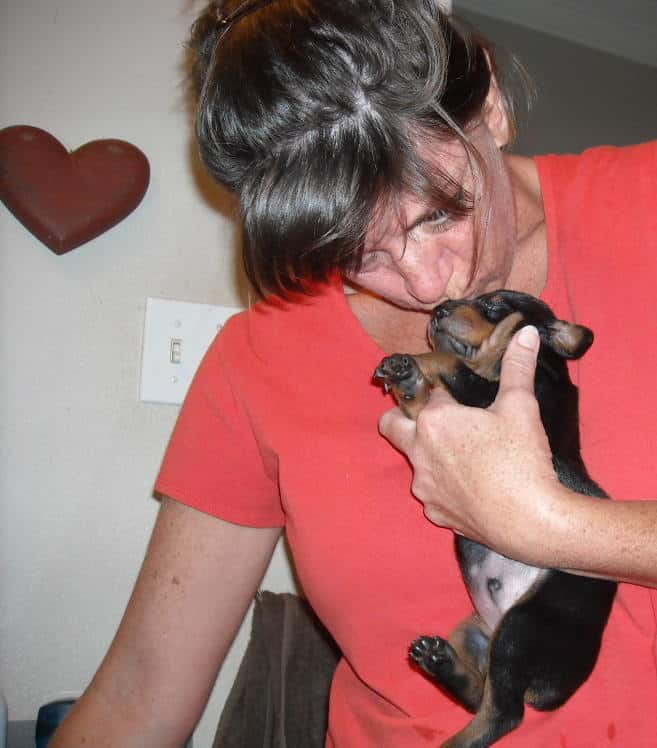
139,297,241,405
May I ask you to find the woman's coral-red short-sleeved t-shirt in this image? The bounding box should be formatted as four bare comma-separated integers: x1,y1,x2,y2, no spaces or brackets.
157,144,657,748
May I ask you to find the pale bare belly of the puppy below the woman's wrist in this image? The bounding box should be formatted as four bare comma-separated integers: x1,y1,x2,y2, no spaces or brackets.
463,551,547,631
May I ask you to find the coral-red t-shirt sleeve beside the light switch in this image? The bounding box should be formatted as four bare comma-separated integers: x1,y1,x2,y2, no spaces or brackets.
155,328,285,527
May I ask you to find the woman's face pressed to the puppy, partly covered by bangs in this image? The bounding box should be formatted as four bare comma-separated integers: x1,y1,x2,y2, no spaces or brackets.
348,123,516,311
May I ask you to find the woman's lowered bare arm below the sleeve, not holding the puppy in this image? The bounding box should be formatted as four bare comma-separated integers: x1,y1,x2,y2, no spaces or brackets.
51,499,280,748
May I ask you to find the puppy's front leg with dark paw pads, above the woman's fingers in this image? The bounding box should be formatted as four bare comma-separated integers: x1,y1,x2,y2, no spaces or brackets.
374,351,458,421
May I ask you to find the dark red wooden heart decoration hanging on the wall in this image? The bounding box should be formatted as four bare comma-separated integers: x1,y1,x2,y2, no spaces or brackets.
0,125,150,255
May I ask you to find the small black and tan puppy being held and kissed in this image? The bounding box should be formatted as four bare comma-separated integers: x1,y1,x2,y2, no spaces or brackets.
375,291,616,748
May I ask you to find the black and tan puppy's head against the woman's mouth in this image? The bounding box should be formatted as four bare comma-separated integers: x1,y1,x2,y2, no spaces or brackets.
429,290,593,380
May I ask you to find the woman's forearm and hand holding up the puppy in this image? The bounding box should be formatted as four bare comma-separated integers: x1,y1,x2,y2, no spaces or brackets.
380,328,657,587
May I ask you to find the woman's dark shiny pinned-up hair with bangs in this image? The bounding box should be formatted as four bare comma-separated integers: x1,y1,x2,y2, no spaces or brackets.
191,0,532,295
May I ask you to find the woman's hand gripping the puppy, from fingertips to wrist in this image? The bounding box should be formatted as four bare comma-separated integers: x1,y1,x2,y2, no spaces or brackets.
380,327,562,563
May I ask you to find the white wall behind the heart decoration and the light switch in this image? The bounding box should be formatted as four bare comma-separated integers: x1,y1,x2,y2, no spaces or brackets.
0,0,292,748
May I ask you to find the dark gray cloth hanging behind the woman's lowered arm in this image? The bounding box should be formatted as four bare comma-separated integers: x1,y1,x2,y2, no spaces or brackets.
213,592,340,748
